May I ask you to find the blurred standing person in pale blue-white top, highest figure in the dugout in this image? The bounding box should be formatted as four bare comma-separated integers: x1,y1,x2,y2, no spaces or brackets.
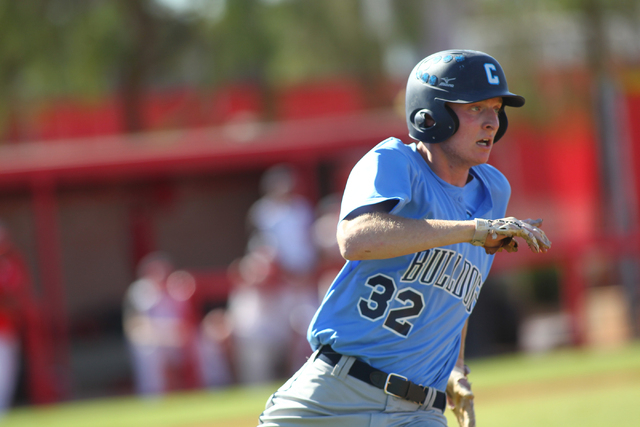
249,165,316,277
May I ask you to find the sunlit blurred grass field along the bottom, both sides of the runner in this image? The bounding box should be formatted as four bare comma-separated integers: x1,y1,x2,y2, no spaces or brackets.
5,344,640,427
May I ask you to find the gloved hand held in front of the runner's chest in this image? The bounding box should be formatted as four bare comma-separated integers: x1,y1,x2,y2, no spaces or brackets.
471,217,551,254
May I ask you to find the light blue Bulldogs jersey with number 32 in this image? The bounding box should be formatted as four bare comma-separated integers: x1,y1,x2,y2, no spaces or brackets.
308,138,511,390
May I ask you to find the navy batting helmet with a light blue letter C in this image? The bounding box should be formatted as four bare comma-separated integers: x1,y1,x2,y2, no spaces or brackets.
405,50,524,143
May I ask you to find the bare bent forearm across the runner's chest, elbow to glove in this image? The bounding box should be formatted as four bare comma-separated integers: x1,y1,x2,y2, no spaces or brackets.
338,213,475,261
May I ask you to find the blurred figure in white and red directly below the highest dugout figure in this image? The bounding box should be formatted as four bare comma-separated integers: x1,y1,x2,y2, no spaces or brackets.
229,241,317,383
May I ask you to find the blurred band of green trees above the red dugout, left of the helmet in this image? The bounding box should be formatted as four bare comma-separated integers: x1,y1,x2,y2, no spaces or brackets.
0,0,430,139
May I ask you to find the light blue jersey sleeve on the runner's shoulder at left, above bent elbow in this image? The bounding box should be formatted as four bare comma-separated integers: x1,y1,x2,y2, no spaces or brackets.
340,138,414,220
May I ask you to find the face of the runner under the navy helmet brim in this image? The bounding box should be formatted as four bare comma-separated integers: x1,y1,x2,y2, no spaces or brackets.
440,98,502,168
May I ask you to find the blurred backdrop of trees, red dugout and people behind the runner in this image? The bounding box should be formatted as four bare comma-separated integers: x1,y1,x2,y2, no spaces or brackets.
0,0,640,414
